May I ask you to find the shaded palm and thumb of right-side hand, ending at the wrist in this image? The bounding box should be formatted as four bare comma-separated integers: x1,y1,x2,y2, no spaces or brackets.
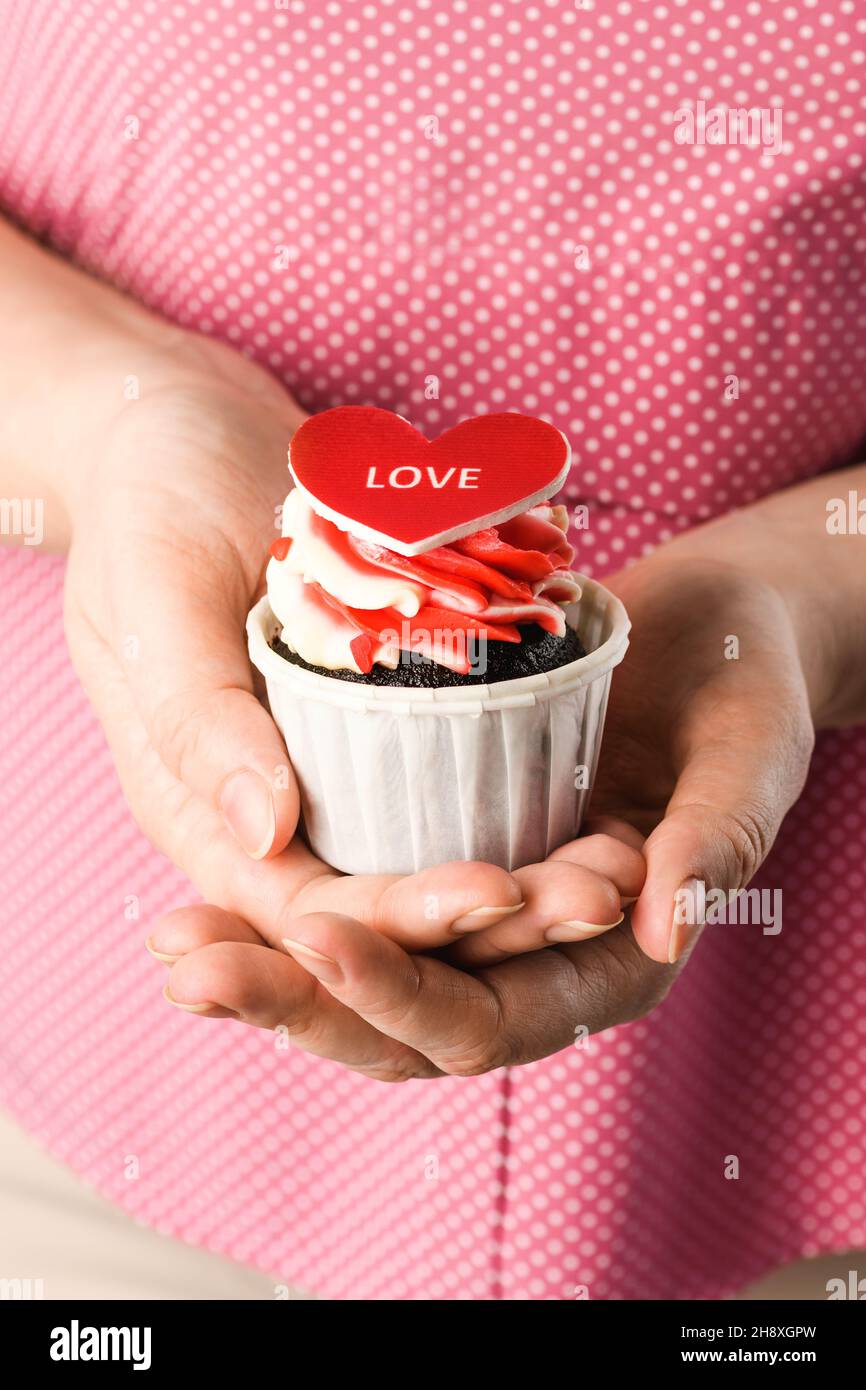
592,544,819,962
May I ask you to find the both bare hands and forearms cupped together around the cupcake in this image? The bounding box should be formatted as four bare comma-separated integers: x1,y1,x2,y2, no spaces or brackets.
0,219,866,1080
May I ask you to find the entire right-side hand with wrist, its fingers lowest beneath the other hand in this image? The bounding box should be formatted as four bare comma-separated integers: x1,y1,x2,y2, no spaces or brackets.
154,467,863,1079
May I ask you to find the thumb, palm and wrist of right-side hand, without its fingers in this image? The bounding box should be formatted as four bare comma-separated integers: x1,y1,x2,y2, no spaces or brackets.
594,466,866,962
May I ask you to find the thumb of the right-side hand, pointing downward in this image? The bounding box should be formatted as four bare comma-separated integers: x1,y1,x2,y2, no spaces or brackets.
631,737,810,965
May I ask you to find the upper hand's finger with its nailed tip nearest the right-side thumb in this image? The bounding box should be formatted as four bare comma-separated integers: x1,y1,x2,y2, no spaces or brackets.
448,858,623,967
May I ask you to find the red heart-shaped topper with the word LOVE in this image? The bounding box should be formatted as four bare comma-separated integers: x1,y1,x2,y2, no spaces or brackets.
289,406,571,555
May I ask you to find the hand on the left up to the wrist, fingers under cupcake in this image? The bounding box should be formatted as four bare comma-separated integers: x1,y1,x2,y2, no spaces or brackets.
65,336,644,960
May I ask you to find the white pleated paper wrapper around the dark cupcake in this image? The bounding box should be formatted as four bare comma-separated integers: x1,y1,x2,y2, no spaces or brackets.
247,575,630,873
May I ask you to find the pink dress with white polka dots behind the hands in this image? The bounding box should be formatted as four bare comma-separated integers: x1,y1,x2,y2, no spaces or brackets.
0,0,866,1300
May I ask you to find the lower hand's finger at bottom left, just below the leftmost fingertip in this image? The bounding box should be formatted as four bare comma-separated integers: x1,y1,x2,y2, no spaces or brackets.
165,924,435,1080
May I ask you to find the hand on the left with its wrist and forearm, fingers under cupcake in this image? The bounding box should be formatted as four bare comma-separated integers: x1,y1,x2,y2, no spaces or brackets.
0,220,631,958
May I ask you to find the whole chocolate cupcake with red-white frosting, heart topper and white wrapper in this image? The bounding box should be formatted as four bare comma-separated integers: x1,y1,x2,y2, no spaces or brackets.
247,406,628,873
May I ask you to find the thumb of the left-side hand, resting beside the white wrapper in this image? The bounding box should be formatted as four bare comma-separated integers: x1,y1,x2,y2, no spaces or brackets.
103,538,299,859
